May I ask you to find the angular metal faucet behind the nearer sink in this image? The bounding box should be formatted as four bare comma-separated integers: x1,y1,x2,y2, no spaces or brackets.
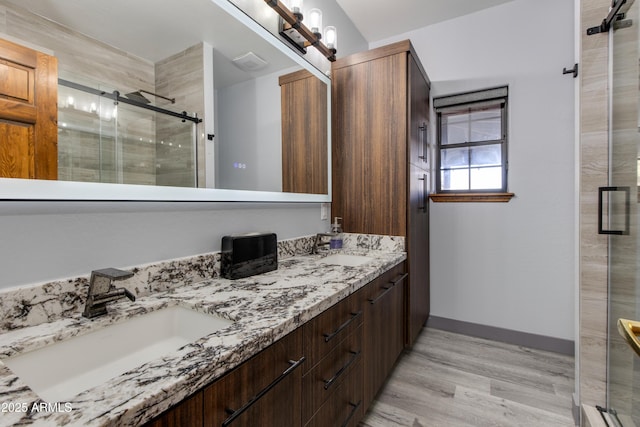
82,268,136,319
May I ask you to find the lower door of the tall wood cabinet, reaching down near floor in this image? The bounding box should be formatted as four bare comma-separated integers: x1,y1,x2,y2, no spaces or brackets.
406,165,430,346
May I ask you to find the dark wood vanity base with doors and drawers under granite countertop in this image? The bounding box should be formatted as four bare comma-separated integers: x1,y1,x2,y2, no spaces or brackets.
147,263,407,427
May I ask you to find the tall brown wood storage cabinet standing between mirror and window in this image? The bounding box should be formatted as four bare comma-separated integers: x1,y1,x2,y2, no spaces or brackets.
332,40,431,345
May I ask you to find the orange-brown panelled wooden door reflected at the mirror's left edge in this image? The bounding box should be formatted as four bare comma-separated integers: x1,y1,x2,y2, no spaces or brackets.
0,39,58,179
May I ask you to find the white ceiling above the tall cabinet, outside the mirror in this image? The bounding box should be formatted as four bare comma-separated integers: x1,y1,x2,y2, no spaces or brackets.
336,0,513,43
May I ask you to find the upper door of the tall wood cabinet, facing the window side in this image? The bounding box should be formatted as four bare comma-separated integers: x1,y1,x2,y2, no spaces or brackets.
407,55,432,170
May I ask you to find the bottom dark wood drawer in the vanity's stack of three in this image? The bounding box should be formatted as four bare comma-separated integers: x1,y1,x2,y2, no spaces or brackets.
305,361,366,427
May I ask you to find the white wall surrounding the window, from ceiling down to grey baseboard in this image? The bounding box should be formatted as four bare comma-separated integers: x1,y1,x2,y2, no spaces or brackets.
372,0,577,339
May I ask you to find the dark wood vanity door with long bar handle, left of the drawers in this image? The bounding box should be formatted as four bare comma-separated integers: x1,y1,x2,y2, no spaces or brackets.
204,330,304,427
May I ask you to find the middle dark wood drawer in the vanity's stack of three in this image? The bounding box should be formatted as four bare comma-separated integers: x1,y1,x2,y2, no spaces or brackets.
302,327,362,420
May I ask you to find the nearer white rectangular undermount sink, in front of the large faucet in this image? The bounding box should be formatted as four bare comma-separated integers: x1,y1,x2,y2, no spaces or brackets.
2,306,233,402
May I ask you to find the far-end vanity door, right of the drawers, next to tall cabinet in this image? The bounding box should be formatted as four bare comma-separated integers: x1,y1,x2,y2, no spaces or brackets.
364,265,407,408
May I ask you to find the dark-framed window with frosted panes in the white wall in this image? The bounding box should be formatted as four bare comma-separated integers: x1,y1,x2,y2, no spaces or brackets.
433,86,508,193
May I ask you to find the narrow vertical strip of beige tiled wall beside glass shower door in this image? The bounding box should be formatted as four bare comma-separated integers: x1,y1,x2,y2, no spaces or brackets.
576,0,611,405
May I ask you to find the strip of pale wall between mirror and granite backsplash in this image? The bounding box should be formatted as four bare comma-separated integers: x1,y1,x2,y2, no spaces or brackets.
0,201,329,289
